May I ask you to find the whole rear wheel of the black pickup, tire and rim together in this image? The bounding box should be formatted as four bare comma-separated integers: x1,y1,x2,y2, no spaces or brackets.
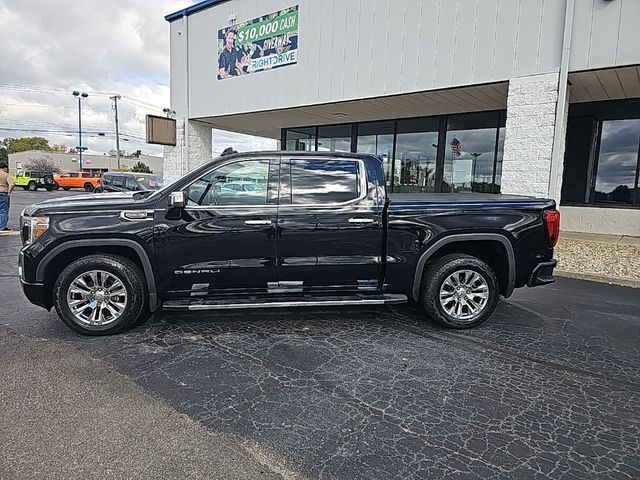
420,253,500,329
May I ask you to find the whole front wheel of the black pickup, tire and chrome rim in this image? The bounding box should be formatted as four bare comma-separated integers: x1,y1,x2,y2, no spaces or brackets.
53,255,149,335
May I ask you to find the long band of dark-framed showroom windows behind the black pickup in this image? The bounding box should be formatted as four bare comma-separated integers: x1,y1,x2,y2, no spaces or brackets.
282,111,506,193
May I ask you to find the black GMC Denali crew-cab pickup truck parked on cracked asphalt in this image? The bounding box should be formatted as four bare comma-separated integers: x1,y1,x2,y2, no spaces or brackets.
19,152,560,335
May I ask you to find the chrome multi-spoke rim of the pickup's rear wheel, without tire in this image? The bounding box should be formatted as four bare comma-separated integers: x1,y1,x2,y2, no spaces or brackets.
440,270,489,321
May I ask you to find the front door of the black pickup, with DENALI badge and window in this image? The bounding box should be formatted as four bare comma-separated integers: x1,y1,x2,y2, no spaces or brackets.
154,156,279,295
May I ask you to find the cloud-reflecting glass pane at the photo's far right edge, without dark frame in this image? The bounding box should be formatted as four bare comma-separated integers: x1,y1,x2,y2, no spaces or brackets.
593,119,640,204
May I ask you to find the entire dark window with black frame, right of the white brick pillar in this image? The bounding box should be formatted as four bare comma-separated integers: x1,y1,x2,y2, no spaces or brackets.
561,100,640,206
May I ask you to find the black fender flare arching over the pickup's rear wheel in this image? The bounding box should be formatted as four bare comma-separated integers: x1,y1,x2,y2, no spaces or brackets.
411,233,516,301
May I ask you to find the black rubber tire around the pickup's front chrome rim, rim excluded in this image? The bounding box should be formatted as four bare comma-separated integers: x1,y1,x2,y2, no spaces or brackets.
53,255,150,335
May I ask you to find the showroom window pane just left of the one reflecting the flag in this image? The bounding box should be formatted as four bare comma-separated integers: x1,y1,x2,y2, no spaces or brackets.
393,117,439,193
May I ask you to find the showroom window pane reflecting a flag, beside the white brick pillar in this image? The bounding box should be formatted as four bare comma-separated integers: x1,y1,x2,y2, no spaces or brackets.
442,113,504,193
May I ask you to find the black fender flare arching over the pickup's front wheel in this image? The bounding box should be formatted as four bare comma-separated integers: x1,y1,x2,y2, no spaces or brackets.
36,238,159,312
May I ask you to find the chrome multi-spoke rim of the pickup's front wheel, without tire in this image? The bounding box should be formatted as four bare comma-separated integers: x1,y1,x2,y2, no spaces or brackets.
67,270,128,325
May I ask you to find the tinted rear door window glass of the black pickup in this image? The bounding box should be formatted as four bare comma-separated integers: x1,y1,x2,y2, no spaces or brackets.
290,159,360,205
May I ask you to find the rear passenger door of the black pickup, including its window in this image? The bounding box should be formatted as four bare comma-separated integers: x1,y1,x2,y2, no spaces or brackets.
278,156,382,291
